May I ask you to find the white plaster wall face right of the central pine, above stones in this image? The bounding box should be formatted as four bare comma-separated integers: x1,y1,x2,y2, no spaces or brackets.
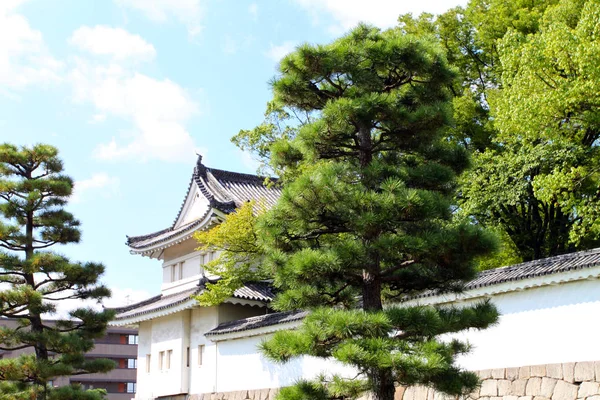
450,280,600,370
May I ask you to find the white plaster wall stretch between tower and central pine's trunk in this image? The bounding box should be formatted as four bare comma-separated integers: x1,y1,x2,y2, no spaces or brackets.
215,335,355,392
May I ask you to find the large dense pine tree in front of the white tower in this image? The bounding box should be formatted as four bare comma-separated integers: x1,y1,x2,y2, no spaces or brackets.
204,25,497,400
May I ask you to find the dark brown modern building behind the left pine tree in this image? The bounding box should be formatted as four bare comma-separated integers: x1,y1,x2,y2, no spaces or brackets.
0,319,138,400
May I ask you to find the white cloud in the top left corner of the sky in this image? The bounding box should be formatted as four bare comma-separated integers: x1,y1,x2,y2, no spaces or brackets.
0,0,63,91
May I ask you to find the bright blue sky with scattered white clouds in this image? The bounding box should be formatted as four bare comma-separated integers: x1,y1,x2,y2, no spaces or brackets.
0,0,465,306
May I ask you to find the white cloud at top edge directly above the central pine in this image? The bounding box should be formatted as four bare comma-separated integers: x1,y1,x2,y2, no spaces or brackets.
295,0,467,34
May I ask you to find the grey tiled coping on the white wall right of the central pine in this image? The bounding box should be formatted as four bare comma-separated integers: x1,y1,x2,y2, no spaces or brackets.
411,248,600,298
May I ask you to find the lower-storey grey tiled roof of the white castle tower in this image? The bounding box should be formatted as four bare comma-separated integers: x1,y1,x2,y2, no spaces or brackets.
113,282,274,320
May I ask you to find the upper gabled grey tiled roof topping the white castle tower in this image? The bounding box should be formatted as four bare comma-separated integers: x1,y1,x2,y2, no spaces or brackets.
127,156,281,249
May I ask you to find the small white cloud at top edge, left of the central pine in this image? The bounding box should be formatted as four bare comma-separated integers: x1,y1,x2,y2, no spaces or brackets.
114,0,203,36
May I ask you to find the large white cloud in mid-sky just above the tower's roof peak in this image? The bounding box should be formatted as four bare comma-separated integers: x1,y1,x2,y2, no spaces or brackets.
69,58,199,162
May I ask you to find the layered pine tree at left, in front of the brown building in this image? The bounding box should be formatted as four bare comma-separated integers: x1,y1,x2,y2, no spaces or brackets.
0,144,114,399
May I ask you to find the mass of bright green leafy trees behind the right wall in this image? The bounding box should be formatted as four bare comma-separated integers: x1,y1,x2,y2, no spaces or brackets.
399,0,599,262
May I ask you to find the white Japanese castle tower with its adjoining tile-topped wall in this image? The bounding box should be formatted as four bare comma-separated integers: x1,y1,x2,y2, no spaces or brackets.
112,159,600,400
